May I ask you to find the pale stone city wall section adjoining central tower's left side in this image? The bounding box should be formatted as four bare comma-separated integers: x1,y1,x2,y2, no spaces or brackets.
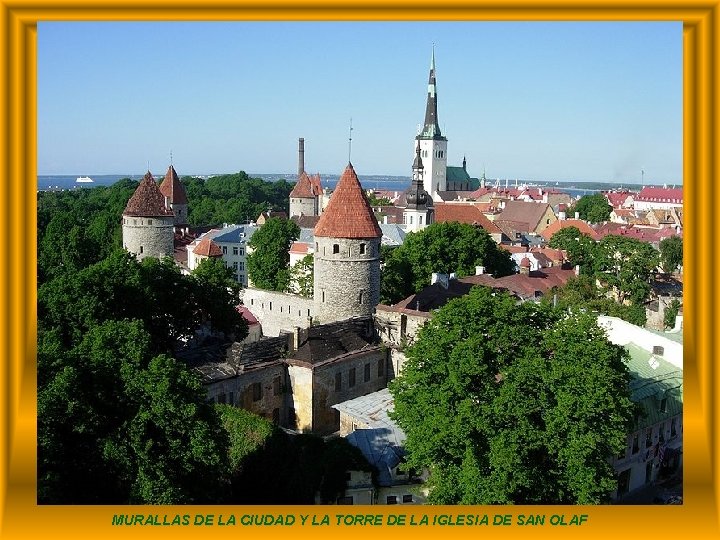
242,288,315,336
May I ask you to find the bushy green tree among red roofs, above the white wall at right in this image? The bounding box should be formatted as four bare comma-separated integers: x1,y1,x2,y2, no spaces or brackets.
594,234,659,304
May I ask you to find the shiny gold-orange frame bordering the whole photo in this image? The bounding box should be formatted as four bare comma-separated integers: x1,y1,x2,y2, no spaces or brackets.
0,0,720,538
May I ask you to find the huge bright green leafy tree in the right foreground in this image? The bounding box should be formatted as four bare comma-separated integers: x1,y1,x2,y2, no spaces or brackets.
390,287,635,504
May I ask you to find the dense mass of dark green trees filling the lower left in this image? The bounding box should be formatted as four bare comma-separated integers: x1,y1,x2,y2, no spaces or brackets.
38,250,247,504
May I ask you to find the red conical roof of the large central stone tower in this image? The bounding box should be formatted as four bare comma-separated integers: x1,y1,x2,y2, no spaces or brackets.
315,163,382,238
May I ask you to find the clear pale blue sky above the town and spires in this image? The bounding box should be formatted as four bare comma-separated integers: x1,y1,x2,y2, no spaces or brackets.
38,22,683,184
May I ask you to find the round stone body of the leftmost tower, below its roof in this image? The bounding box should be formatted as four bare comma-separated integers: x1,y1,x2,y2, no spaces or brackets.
122,216,174,260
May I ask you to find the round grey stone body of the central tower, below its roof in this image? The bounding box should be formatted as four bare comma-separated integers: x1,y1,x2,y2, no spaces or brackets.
314,237,380,324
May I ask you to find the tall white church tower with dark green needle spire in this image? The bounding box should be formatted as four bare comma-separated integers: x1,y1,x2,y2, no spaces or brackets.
415,48,447,199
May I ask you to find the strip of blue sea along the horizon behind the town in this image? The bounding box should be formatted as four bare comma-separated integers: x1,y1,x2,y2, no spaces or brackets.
37,173,643,198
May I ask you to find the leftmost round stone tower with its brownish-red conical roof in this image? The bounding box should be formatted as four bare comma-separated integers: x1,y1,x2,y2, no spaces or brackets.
122,171,175,259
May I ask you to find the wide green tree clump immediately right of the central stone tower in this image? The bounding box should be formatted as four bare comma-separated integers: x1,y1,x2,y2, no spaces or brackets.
380,222,514,304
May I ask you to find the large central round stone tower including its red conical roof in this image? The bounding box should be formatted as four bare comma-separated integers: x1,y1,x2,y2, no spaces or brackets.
314,163,382,323
